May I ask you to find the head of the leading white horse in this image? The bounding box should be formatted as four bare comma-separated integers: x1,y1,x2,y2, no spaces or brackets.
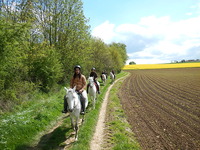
65,86,78,112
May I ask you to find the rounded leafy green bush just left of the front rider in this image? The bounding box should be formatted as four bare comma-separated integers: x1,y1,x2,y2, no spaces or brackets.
29,44,63,91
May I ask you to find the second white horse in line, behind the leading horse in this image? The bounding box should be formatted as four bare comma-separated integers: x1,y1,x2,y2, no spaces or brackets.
88,77,100,109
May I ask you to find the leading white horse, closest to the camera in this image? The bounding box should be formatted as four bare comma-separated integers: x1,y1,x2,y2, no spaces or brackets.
65,87,88,141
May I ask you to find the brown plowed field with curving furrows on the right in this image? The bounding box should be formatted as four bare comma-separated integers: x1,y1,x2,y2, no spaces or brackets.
119,68,200,150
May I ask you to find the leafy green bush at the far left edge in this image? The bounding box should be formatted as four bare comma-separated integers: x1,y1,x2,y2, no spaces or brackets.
0,20,33,110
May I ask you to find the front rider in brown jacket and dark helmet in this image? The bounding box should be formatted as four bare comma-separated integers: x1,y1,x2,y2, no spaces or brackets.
62,65,86,115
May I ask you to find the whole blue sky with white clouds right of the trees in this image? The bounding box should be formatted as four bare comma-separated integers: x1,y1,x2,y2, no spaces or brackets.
82,0,200,64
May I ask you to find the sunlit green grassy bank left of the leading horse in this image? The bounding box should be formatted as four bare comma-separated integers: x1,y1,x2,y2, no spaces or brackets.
0,90,63,150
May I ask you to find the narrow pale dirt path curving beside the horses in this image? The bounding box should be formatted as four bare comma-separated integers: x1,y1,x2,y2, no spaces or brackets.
90,78,125,150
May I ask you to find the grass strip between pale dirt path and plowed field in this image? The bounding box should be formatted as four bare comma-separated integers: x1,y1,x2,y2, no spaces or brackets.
104,72,140,150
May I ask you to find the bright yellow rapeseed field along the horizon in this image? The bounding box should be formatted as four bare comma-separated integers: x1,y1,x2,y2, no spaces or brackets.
122,62,200,70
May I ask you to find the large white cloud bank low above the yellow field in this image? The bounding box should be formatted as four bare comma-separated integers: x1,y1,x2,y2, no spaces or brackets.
92,16,200,64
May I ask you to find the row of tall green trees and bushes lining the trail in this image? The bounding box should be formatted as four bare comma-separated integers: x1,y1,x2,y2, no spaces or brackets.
0,0,127,110
